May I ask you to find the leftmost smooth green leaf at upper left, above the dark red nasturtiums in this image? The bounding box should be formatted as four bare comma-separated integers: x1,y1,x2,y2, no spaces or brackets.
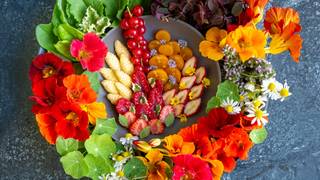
36,23,58,52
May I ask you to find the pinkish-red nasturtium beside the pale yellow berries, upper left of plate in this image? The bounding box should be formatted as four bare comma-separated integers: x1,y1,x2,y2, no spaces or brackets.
70,33,108,72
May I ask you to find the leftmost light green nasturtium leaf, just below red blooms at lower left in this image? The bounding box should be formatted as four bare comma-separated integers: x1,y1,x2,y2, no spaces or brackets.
56,136,79,156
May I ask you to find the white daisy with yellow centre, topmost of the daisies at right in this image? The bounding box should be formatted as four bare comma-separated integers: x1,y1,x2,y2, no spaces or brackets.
262,78,282,100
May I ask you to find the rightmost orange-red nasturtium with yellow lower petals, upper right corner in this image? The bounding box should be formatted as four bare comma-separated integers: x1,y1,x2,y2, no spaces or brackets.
264,7,302,62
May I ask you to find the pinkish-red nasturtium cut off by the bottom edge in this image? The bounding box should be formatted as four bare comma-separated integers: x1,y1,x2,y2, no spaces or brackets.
172,154,212,180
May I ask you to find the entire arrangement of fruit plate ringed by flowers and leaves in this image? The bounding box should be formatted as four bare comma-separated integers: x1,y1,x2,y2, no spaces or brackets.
29,0,302,180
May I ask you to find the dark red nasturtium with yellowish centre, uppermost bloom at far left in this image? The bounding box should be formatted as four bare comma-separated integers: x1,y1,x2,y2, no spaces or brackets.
29,53,74,84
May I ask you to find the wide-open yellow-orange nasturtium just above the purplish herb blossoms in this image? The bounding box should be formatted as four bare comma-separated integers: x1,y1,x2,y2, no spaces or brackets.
227,26,267,62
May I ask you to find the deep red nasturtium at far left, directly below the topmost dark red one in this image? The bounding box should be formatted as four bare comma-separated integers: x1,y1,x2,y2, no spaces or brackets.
30,78,66,114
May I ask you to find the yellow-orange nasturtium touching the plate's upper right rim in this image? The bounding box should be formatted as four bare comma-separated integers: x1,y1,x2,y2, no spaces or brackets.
199,27,227,61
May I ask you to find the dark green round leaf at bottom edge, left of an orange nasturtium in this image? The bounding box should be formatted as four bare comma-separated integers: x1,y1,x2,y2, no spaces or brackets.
124,157,147,179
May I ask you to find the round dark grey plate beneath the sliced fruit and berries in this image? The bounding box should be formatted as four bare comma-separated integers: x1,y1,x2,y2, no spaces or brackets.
98,16,221,140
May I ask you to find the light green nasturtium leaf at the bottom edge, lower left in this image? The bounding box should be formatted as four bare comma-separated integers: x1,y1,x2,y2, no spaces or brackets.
84,154,112,180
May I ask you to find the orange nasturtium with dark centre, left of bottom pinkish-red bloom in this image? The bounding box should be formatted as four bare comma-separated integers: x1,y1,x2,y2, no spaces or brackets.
140,149,170,180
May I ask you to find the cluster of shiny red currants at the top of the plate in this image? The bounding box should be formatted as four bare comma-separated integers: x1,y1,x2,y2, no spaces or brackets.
120,5,150,72
